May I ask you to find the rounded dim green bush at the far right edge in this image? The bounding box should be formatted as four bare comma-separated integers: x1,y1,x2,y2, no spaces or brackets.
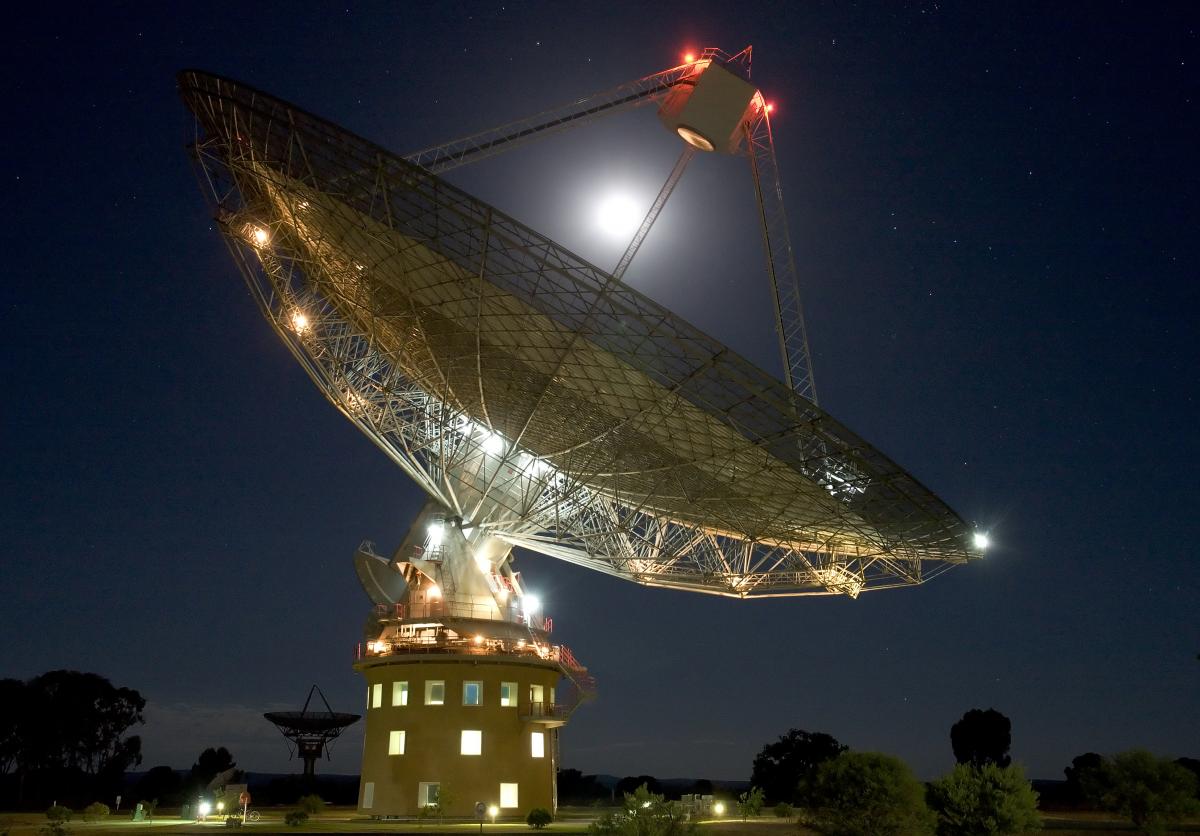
1104,750,1200,834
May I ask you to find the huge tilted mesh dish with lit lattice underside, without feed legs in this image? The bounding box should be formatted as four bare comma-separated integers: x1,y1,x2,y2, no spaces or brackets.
179,71,980,597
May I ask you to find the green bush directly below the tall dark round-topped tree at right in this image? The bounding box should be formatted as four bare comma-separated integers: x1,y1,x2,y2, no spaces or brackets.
929,763,1042,836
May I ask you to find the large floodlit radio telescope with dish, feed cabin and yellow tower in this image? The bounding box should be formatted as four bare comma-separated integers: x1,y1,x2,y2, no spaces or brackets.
179,48,985,816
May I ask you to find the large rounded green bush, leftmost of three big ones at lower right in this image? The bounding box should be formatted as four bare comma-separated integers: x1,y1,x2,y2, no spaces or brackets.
806,752,935,836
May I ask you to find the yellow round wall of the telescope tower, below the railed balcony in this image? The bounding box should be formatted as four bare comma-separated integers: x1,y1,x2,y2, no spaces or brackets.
355,655,559,819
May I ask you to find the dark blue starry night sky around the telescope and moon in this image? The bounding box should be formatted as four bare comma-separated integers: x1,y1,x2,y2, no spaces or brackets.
0,1,1200,778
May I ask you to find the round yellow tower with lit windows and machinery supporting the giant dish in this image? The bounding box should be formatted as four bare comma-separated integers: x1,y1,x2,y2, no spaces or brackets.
354,503,594,819
